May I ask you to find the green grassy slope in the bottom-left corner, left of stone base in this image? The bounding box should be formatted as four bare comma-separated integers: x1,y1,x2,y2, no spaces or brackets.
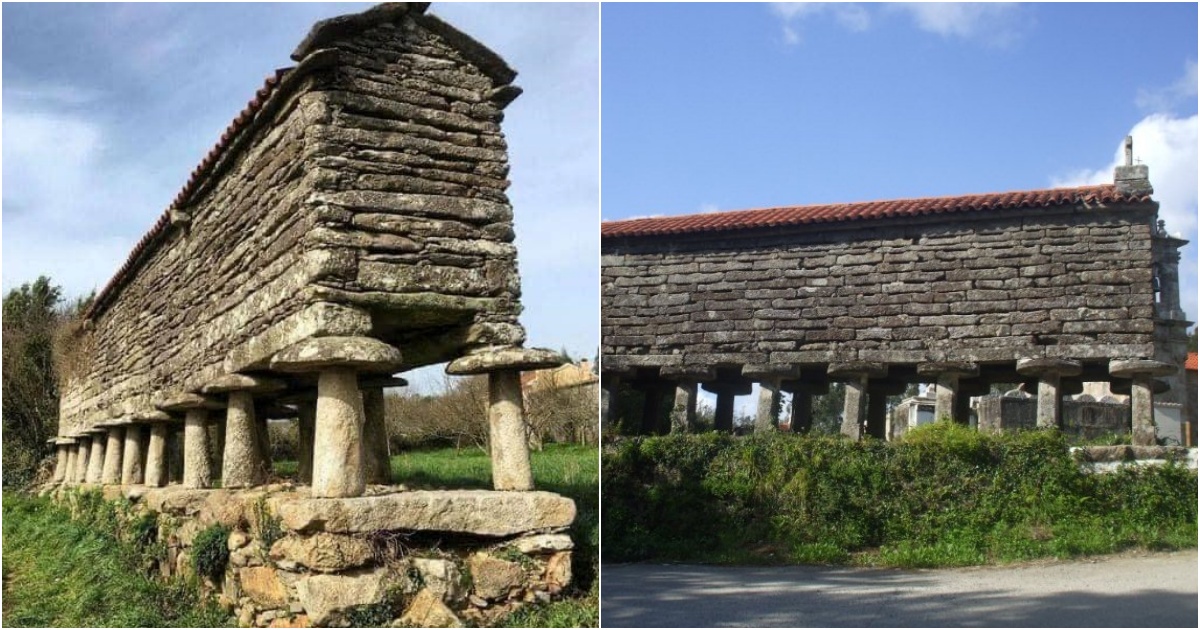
4,492,226,628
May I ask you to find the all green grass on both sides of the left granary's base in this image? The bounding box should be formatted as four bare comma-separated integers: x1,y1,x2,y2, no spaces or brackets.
4,445,600,628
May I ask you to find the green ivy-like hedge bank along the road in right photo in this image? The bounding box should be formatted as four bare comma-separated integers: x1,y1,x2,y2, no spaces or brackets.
601,422,1196,566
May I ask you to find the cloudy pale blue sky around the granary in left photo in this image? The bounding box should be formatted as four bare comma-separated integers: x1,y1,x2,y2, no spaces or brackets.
2,4,600,386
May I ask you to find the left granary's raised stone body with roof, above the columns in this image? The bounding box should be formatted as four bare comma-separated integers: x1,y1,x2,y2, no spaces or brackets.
60,4,524,437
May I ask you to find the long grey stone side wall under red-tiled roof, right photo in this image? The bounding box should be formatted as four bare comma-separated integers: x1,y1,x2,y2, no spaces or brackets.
601,208,1157,371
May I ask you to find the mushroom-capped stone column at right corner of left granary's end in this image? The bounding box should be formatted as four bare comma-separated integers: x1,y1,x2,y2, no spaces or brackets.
446,347,563,490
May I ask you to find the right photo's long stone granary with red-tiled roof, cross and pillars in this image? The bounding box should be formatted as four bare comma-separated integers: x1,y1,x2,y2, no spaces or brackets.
601,139,1190,444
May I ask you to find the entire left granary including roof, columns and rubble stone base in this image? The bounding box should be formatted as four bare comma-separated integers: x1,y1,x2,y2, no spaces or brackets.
43,4,575,626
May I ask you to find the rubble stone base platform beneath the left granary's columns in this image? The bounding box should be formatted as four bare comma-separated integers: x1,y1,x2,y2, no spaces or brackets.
50,484,575,628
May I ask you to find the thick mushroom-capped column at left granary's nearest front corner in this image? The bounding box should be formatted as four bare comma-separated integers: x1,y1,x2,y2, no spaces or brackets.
271,337,402,498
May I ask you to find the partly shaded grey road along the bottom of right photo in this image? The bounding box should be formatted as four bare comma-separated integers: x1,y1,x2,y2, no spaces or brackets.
600,550,1198,628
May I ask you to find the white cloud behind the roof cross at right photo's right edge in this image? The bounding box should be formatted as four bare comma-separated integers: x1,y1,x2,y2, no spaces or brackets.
1052,114,1200,318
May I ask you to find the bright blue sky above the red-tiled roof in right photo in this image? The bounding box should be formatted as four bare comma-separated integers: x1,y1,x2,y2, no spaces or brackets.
601,4,1198,417
